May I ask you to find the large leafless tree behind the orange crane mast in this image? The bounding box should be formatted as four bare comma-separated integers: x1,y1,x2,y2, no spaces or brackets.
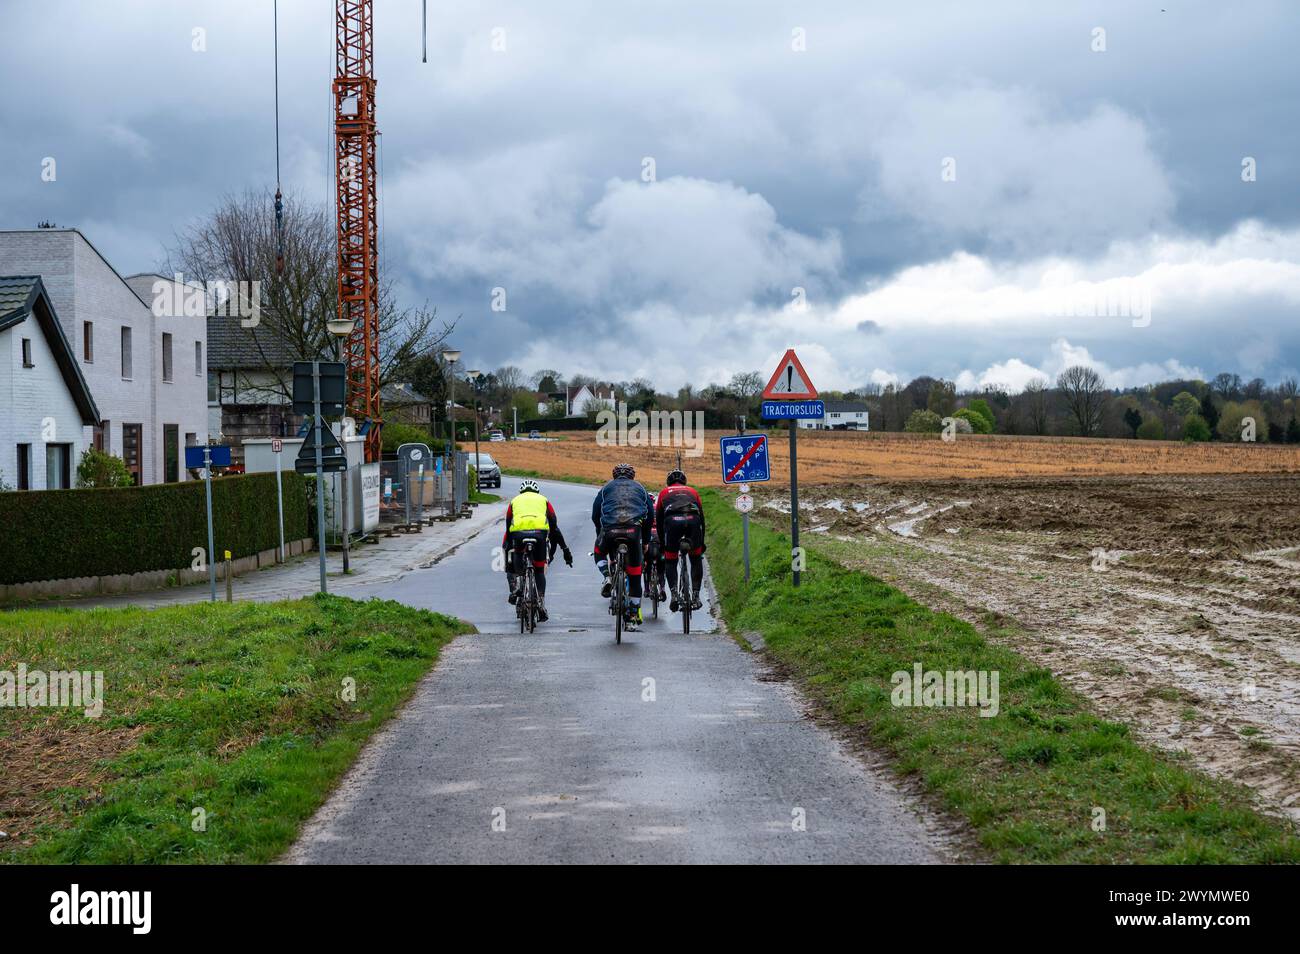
165,191,455,398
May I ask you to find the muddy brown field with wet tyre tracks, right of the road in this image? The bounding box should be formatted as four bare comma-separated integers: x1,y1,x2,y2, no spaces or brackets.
755,478,1300,820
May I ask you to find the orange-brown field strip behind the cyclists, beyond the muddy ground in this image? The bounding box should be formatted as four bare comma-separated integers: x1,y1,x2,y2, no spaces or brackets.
485,430,1300,486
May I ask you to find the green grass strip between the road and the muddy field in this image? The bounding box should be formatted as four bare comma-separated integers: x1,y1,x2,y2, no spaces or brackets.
705,491,1300,864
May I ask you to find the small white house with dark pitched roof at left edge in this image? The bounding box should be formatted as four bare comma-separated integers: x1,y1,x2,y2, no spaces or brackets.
0,276,99,490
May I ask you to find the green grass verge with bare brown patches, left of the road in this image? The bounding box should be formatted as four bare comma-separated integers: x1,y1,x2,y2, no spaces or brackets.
0,597,472,864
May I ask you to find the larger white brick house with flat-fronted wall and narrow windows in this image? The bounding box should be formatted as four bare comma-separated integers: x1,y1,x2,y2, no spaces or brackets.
0,229,208,483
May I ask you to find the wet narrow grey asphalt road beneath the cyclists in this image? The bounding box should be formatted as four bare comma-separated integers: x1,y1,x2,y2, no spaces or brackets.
286,478,941,863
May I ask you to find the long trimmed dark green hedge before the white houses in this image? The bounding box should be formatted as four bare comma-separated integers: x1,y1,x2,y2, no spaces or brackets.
0,472,308,584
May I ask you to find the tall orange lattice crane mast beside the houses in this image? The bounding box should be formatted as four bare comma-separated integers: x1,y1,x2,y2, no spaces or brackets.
334,0,382,463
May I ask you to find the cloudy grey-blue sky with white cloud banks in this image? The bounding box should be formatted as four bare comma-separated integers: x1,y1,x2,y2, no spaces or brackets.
0,0,1300,389
